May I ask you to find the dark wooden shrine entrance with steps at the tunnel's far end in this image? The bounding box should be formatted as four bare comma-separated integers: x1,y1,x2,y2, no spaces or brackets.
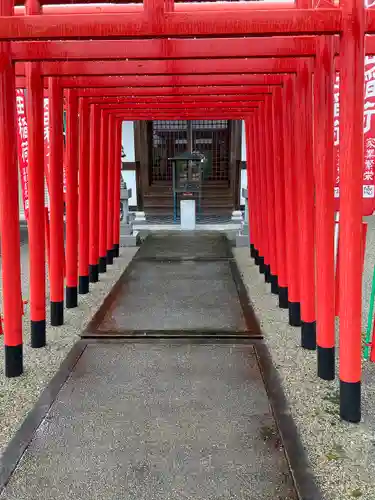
136,120,241,218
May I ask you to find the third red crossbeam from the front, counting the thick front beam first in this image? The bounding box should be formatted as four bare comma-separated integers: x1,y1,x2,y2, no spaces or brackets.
16,57,309,76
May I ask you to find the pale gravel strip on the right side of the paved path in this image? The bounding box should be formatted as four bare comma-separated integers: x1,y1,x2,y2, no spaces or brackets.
234,218,375,500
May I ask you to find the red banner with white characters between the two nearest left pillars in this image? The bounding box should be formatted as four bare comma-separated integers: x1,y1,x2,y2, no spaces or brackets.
16,89,29,220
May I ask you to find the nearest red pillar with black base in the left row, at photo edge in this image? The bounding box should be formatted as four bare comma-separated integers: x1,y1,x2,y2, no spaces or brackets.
0,0,23,377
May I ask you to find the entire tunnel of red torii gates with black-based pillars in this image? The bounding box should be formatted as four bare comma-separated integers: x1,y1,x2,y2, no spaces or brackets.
0,0,375,422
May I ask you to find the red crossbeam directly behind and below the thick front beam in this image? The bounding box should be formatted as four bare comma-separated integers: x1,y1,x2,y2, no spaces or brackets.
11,36,324,61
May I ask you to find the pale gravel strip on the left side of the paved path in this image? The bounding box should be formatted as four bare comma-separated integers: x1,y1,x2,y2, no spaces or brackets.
0,244,138,453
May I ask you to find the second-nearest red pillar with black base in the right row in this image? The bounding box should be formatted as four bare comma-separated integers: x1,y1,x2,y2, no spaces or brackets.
314,36,335,380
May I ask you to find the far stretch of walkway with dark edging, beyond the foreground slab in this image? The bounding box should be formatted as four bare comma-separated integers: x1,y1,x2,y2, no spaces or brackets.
85,232,260,337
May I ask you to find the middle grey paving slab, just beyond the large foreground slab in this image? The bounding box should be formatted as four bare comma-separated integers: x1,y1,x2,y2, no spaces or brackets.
97,261,247,333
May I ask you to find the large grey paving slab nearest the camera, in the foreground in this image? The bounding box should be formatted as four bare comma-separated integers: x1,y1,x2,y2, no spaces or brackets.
0,342,296,500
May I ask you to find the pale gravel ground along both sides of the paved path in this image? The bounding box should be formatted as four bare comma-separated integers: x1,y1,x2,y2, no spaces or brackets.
0,218,375,500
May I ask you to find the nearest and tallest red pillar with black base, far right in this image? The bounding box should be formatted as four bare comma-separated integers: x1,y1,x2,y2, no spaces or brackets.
339,0,365,422
